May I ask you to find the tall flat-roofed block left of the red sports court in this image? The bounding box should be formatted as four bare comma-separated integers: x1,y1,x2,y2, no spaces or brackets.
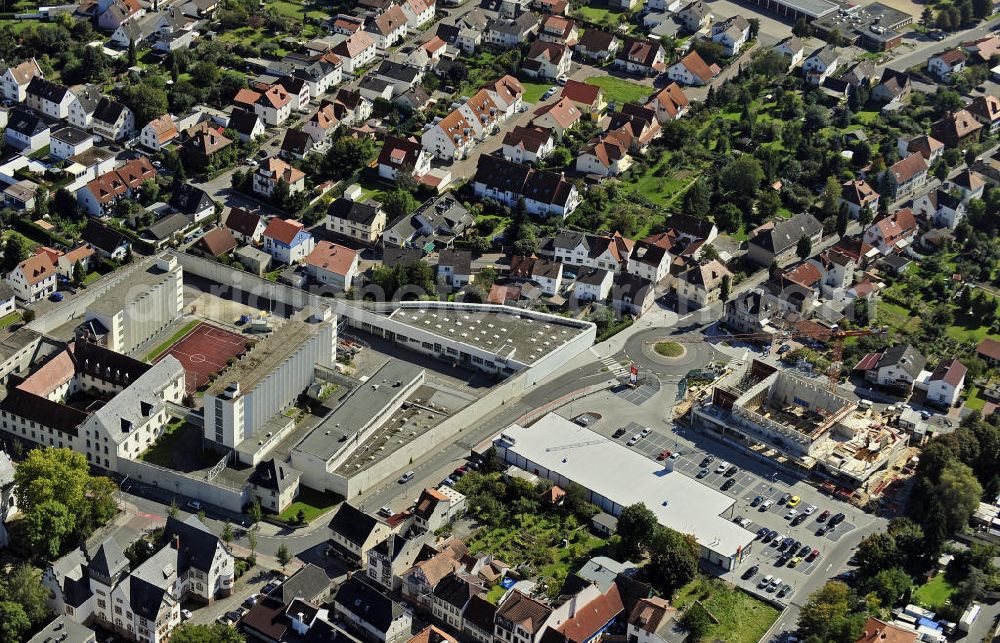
84,255,184,353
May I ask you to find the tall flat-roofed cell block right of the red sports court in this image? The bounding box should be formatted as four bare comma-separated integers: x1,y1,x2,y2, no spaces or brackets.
205,307,337,448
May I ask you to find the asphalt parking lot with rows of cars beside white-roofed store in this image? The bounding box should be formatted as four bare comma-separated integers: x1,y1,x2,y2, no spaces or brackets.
584,413,872,602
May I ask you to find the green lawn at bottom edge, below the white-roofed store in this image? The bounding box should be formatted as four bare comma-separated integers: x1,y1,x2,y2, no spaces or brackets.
670,578,780,643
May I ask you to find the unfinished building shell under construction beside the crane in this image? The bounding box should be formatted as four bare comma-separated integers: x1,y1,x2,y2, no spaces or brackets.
691,360,907,487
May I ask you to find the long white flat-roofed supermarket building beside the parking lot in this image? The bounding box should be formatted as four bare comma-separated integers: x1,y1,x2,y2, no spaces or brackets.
494,413,755,570
